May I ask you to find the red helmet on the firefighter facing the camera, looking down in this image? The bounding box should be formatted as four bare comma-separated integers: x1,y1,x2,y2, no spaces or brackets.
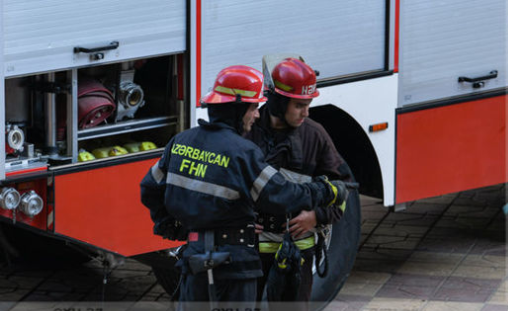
272,58,319,99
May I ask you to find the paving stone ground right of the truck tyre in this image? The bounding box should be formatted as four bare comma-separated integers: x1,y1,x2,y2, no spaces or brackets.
327,185,508,311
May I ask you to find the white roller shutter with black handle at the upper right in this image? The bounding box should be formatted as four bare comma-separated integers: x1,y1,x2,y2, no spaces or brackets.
399,0,508,106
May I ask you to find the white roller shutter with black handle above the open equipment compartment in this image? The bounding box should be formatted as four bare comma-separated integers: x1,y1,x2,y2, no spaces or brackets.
1,0,186,77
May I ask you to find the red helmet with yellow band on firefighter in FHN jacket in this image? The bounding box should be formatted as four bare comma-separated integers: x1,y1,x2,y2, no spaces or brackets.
200,65,266,104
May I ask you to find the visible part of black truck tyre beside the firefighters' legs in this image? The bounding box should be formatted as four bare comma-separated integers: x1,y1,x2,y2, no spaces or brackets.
311,186,361,310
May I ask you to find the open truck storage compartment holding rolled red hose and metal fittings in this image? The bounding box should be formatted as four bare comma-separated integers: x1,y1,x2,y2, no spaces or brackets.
5,54,185,175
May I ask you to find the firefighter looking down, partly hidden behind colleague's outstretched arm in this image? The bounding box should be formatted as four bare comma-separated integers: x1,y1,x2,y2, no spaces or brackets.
246,58,351,310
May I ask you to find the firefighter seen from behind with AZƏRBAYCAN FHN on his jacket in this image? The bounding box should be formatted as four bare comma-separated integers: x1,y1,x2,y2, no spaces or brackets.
141,66,347,309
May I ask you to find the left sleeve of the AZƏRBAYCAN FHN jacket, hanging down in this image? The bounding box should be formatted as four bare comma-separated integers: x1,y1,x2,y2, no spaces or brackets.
140,142,172,224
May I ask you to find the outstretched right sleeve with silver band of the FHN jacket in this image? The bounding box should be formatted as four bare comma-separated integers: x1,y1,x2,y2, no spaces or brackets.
245,148,334,215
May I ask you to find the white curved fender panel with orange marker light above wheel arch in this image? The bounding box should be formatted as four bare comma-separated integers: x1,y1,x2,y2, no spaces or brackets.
311,74,398,206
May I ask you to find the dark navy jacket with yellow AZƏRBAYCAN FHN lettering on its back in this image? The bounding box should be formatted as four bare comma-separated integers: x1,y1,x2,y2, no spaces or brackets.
141,120,333,278
